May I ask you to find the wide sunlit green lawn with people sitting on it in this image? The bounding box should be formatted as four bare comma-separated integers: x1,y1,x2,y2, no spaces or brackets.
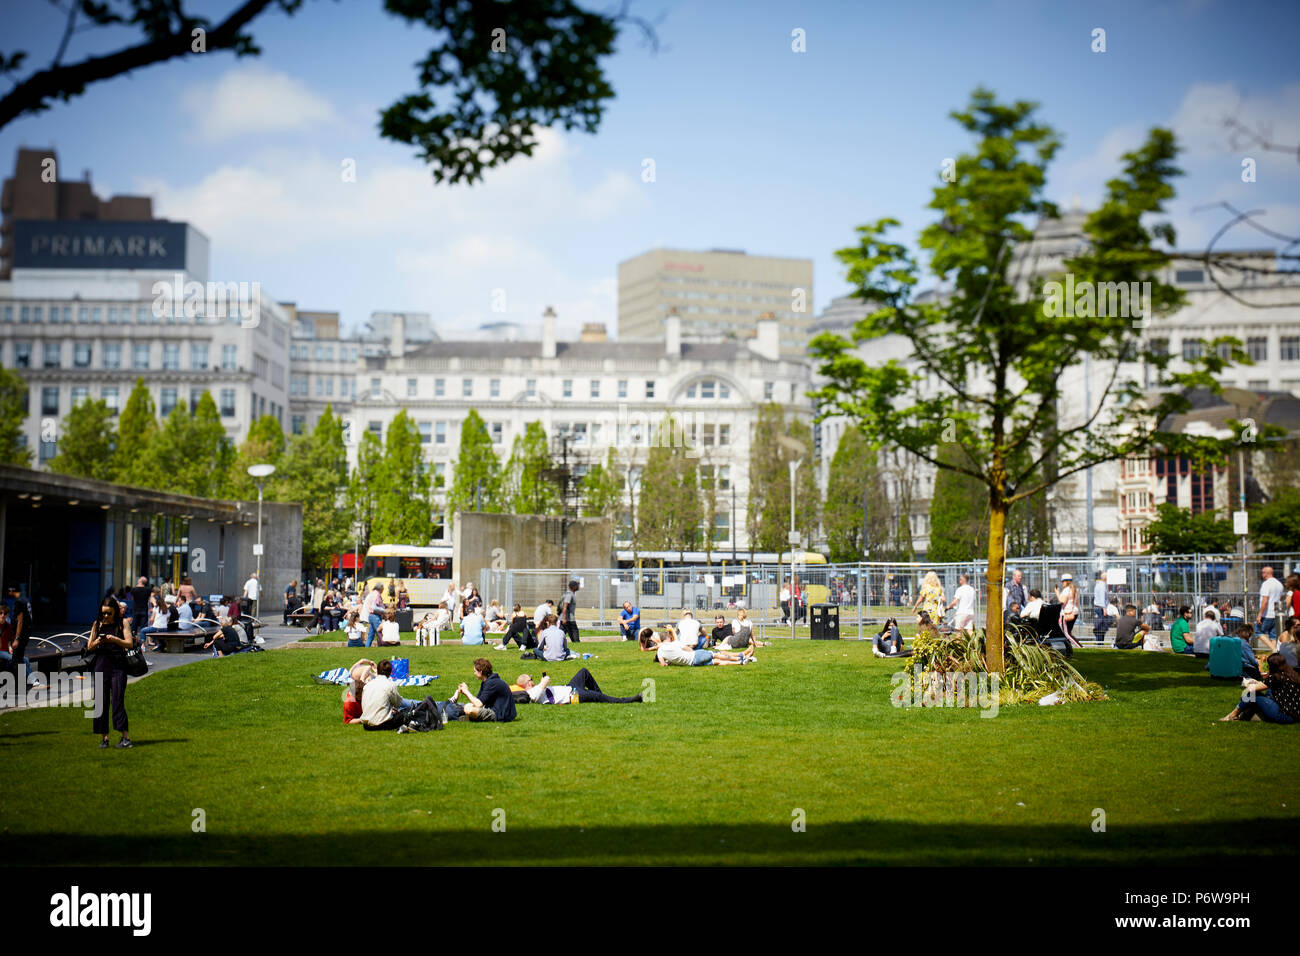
0,641,1300,865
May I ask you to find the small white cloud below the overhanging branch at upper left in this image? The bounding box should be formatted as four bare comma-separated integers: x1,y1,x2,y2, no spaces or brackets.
181,64,337,142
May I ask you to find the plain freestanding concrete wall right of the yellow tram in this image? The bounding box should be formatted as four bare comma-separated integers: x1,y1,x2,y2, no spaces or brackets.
451,511,614,581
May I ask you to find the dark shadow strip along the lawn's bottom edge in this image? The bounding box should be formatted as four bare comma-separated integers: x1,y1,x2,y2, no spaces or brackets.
0,814,1300,866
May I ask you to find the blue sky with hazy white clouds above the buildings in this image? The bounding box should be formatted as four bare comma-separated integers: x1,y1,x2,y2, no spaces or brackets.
0,0,1300,337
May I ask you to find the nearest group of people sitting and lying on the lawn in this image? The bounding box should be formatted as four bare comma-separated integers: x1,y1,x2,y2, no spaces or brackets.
343,657,642,734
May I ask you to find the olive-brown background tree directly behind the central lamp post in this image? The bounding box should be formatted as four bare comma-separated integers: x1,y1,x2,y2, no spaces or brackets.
746,402,822,554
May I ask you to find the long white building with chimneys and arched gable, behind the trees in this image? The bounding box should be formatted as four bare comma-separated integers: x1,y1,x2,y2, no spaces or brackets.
350,310,811,551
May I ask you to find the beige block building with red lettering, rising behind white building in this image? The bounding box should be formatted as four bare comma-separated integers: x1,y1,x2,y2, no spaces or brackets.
619,248,813,359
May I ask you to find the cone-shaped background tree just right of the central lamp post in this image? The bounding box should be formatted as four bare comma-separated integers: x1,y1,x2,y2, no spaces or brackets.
822,427,893,562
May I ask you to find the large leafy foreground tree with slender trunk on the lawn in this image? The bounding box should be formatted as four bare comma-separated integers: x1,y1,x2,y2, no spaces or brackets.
811,88,1244,671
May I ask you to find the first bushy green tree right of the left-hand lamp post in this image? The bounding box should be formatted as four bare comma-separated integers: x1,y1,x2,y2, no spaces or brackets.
280,406,351,567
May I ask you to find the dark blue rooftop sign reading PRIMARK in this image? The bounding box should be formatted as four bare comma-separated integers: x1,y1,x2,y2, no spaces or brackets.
13,220,207,273
